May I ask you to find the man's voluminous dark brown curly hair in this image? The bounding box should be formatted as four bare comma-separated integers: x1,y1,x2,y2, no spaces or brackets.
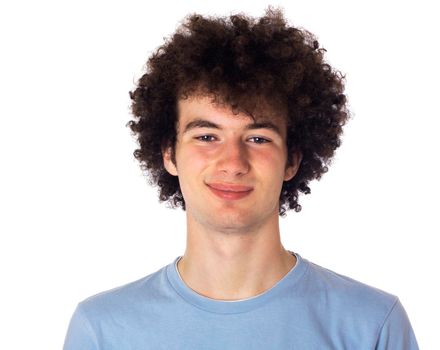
127,7,350,217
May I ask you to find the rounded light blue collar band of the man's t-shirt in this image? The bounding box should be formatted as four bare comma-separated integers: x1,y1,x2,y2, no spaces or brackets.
166,250,308,314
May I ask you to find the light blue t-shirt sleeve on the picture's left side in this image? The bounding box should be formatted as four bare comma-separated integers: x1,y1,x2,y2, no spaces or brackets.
63,304,99,350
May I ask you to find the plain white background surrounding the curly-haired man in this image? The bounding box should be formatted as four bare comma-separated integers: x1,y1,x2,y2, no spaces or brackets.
0,0,440,350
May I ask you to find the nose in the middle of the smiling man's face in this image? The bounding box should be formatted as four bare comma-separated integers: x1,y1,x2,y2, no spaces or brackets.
217,140,250,176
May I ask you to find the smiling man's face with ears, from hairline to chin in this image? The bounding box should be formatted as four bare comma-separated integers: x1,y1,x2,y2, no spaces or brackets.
164,96,300,233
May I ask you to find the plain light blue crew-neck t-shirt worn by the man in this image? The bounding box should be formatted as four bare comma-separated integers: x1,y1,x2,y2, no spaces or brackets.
64,252,418,350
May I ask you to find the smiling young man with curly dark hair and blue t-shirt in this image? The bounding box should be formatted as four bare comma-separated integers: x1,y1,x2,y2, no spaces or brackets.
64,8,418,350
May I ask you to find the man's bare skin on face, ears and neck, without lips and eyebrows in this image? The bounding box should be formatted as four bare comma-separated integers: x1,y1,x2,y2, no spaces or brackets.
163,95,301,300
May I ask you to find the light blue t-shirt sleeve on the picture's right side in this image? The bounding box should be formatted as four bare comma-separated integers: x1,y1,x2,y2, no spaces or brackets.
375,298,419,350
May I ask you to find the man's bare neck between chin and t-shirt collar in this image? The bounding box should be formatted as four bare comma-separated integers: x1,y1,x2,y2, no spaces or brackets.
177,211,296,300
